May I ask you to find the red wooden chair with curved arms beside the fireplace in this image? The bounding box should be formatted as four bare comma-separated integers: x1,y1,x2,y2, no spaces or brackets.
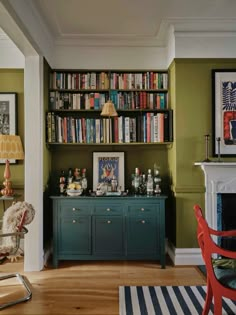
194,205,236,315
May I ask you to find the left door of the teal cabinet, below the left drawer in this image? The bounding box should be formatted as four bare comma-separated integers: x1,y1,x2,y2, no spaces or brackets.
58,216,91,255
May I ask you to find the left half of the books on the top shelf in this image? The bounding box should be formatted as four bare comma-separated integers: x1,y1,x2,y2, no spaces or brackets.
50,71,109,90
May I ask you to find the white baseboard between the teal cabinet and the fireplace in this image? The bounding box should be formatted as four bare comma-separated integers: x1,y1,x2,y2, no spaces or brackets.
167,243,204,266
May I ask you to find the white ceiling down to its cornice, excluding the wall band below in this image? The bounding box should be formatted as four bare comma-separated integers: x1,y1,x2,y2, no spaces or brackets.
25,0,236,46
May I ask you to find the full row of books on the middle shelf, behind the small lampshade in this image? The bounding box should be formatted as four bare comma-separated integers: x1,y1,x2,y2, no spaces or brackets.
49,90,168,110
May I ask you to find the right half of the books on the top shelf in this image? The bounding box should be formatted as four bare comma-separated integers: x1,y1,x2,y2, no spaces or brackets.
110,71,168,90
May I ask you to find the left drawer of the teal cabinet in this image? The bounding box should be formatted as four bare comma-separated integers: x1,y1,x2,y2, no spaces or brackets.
61,200,92,216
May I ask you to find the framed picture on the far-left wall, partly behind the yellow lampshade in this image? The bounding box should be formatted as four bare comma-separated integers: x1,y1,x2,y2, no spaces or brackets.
0,93,17,164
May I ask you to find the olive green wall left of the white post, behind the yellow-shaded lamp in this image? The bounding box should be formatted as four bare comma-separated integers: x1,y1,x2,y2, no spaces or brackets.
0,69,24,189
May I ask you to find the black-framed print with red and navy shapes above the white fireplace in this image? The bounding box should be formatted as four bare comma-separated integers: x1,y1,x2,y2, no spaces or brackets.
212,69,236,156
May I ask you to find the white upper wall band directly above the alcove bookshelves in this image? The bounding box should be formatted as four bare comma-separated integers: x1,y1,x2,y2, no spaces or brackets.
51,46,169,69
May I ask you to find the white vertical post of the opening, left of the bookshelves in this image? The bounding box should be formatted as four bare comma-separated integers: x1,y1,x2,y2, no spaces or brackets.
24,55,44,271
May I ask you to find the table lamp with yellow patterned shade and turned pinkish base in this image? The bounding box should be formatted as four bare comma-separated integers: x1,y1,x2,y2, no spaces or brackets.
0,135,24,197
